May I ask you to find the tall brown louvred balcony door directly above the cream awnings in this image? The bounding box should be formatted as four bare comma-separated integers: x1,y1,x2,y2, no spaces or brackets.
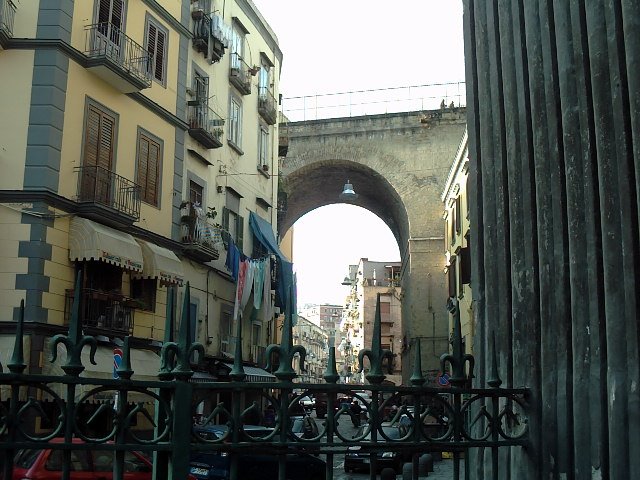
80,104,116,206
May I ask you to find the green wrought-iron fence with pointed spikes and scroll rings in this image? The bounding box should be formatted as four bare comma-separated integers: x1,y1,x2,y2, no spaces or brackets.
0,276,528,480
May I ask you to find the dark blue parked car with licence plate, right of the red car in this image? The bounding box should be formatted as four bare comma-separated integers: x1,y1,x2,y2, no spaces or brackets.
190,425,326,480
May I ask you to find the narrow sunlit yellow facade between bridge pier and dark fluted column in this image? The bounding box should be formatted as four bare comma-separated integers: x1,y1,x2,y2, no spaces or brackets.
442,127,473,353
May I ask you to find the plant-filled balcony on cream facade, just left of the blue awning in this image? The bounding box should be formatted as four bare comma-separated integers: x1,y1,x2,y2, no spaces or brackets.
181,202,221,262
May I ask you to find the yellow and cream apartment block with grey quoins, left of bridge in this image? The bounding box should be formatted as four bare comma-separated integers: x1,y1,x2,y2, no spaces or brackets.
0,0,282,390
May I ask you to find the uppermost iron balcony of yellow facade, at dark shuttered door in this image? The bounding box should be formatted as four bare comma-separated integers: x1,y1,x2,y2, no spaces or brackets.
84,22,153,93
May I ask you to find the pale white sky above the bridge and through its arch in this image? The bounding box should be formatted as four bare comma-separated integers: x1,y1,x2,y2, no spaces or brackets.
253,0,464,306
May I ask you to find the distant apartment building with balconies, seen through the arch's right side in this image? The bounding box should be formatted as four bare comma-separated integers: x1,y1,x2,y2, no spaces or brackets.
339,258,402,385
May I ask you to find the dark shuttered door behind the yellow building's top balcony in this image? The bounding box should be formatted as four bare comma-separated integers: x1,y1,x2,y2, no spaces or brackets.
93,0,125,60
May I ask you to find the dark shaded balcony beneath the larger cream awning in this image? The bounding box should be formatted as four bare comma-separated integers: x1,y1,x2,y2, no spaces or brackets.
64,288,136,336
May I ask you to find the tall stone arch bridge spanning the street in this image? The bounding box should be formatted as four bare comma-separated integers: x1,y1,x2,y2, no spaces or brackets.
278,107,466,383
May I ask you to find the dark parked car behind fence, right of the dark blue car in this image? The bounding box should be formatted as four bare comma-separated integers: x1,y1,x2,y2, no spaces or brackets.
344,424,411,473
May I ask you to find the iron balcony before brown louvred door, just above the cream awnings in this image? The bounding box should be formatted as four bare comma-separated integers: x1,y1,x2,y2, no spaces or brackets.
76,165,140,225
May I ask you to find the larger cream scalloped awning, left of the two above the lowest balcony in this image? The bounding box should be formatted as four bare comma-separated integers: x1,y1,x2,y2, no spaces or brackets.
69,217,143,272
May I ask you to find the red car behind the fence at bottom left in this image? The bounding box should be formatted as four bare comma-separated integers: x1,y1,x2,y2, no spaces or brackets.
12,439,154,480
